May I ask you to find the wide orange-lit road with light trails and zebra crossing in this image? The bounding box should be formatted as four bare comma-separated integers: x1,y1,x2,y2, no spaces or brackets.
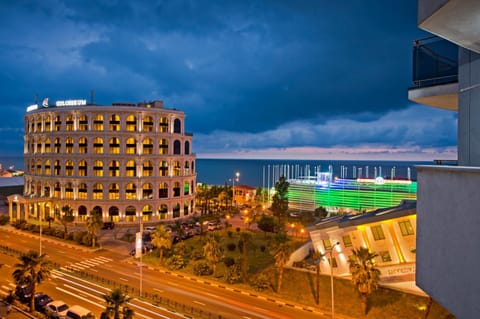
0,227,348,319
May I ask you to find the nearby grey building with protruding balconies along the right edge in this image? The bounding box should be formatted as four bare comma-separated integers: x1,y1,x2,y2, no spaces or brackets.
408,0,480,319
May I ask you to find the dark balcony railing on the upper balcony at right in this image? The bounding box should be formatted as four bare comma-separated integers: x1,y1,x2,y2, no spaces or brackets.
413,36,458,88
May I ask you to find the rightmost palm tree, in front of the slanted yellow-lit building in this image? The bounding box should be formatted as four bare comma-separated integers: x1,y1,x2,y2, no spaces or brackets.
349,247,380,314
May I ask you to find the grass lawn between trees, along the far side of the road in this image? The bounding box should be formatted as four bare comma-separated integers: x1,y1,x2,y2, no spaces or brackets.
143,228,455,319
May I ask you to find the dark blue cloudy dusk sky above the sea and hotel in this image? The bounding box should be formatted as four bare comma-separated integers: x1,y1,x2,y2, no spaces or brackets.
0,0,457,160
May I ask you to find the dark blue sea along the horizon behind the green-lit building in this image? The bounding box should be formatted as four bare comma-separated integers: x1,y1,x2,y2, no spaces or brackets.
0,155,433,188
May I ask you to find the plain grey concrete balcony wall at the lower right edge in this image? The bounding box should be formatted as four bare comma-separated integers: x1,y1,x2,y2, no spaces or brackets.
416,166,480,318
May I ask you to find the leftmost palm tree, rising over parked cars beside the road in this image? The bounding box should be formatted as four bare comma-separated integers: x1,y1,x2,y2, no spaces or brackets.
12,250,53,312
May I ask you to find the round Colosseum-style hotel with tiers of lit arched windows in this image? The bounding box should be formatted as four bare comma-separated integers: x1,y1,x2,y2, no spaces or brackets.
10,100,196,223
